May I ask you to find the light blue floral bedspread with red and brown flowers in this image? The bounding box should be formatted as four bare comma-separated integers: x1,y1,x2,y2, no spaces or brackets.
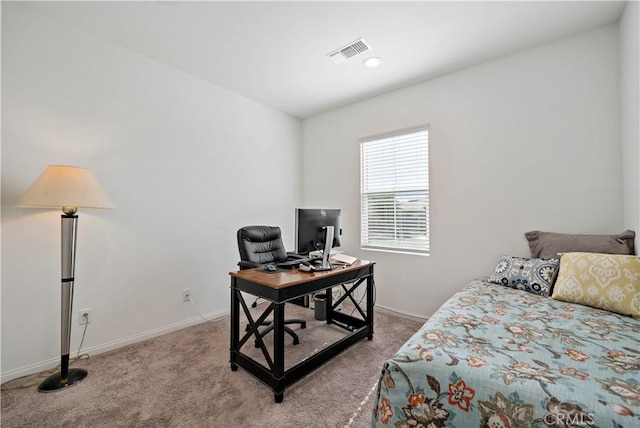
372,279,640,428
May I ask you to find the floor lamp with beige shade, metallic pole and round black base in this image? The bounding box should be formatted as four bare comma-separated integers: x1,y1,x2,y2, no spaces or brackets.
16,165,114,392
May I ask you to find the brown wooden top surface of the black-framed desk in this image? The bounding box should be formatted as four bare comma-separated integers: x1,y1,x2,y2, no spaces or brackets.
229,260,374,289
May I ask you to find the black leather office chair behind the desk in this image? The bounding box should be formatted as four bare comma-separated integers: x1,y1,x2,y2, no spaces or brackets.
238,226,307,347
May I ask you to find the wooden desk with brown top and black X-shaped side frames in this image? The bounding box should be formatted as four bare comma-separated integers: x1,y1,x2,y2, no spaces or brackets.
229,260,374,403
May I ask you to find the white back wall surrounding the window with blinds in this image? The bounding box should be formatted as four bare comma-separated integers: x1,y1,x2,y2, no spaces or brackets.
303,25,623,316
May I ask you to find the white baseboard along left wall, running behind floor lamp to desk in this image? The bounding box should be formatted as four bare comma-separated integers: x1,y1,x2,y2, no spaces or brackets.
0,309,229,383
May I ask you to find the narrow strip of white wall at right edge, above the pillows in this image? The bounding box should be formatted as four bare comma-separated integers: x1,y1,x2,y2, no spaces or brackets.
620,1,640,247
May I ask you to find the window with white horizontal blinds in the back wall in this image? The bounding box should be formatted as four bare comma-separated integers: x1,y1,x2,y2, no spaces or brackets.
359,125,429,255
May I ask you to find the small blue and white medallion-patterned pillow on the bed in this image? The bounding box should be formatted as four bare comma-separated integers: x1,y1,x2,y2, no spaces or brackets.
488,255,560,297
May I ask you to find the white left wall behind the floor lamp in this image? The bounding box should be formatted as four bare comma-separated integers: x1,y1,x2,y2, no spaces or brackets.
1,2,301,381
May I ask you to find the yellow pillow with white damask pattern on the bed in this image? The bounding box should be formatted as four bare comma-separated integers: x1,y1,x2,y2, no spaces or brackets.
551,253,640,319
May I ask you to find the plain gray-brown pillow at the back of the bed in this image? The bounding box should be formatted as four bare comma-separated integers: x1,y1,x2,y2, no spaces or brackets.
524,230,636,258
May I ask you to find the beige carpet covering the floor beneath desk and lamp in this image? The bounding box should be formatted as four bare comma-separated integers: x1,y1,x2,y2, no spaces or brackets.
0,305,422,428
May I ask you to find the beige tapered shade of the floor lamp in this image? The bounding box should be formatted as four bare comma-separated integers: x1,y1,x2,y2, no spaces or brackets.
16,165,115,209
